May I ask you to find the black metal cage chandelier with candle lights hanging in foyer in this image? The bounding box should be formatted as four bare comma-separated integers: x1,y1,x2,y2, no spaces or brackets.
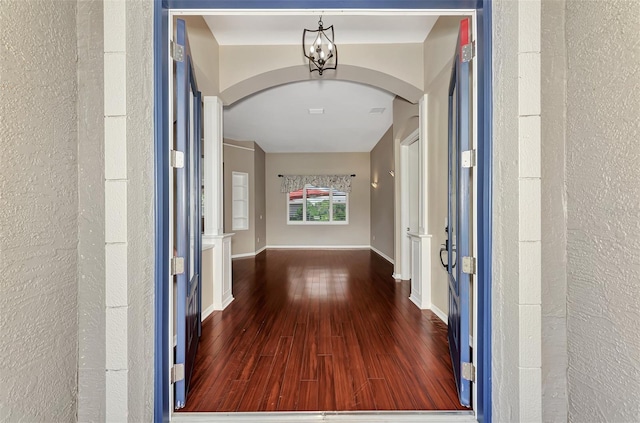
302,16,338,75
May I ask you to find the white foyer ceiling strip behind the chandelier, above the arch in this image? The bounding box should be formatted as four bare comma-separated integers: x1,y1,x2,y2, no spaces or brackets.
204,14,438,47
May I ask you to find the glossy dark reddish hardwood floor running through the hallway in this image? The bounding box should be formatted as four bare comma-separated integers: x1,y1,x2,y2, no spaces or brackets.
183,250,464,412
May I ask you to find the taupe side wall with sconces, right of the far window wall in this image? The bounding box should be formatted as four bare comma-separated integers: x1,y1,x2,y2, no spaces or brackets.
370,126,395,260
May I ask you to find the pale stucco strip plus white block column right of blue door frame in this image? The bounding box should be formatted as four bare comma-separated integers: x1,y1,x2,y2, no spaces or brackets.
491,0,544,422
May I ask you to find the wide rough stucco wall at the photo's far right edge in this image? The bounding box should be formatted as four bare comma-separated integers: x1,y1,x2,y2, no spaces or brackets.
566,0,640,422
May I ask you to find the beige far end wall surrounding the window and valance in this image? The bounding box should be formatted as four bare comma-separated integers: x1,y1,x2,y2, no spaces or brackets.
265,153,371,247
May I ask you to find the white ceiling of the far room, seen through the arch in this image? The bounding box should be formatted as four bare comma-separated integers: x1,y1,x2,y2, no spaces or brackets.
224,80,394,153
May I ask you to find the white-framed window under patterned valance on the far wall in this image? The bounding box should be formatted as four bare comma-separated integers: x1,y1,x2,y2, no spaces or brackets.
287,184,349,224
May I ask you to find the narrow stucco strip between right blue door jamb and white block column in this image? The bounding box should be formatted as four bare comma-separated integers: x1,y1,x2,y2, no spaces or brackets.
491,0,521,422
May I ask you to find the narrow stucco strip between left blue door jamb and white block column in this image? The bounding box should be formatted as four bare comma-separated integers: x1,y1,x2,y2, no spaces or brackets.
126,0,155,422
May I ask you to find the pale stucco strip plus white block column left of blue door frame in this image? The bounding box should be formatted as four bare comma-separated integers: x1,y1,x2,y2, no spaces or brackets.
105,0,155,421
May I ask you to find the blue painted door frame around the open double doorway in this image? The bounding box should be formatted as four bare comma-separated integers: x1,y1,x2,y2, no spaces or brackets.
154,0,492,423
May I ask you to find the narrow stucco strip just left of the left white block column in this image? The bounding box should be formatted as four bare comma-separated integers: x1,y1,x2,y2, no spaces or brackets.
76,0,106,422
